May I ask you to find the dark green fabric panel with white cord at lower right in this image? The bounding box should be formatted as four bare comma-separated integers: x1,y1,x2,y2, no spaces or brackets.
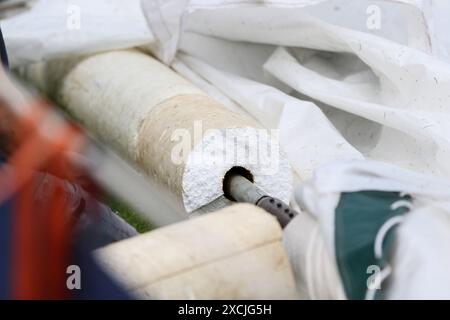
335,191,411,299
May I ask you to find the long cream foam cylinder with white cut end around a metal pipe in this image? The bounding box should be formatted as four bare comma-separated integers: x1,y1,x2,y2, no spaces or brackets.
23,50,292,212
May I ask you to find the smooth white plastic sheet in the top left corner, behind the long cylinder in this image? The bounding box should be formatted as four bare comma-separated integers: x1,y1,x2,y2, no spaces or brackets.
1,0,154,65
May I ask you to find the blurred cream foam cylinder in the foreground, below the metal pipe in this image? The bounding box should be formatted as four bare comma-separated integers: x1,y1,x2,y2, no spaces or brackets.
95,204,297,299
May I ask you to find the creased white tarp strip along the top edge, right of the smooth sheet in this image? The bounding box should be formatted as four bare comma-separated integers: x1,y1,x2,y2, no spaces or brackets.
142,0,436,63
